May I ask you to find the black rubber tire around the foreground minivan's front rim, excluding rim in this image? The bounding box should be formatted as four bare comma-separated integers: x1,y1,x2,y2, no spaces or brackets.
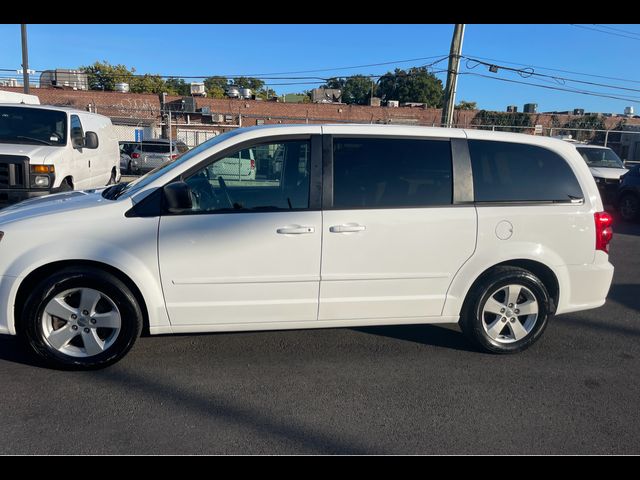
19,269,142,369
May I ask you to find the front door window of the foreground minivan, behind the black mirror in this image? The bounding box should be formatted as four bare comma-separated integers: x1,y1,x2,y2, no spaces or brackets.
185,140,311,212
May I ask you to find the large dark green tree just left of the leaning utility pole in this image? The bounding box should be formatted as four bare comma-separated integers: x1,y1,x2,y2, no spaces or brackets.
377,67,444,108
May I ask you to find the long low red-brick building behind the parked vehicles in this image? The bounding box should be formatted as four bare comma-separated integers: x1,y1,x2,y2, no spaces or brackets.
5,87,640,146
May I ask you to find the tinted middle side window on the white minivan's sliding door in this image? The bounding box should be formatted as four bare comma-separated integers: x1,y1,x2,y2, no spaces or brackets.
333,138,452,208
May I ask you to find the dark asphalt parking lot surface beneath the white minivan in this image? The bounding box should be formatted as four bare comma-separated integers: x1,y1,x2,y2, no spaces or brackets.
0,224,640,455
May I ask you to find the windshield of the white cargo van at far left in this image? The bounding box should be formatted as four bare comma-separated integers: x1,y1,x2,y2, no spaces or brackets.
0,107,67,146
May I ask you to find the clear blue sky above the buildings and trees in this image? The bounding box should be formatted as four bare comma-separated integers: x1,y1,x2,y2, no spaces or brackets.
0,24,640,113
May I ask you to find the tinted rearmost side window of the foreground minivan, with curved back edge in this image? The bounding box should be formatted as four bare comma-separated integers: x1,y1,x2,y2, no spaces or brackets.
469,140,583,202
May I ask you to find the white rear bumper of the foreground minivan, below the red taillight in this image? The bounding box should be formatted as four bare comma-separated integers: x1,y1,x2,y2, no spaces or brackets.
556,252,614,314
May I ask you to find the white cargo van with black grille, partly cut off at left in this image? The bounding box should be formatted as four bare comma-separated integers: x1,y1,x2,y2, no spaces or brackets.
0,104,120,206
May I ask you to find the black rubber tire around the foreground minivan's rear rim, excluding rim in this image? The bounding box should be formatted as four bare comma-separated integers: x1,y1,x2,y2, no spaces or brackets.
463,268,550,353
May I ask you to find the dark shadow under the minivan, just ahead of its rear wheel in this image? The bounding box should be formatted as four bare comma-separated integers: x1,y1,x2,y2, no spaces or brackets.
352,325,478,353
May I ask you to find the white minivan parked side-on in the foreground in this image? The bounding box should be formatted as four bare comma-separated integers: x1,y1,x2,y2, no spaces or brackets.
0,125,613,368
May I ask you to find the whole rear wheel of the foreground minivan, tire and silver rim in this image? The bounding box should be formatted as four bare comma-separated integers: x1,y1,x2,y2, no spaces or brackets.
460,266,550,353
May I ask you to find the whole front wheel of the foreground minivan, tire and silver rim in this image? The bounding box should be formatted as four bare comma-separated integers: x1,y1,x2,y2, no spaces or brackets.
17,267,143,370
